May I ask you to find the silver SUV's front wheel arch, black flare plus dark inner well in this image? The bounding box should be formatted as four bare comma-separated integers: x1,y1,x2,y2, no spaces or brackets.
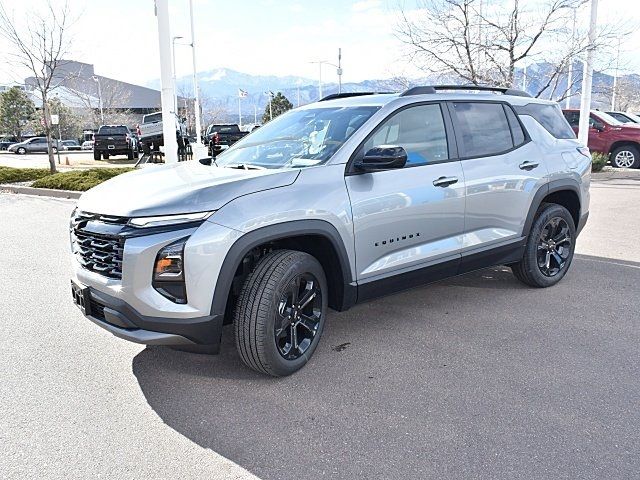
211,220,357,315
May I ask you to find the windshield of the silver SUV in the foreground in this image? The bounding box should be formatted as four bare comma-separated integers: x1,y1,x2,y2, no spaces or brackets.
216,107,380,168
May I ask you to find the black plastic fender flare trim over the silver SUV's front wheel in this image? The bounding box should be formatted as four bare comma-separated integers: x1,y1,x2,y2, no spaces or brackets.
211,220,357,315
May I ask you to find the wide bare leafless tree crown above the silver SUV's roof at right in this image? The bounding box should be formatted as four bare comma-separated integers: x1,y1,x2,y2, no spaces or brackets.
396,0,611,100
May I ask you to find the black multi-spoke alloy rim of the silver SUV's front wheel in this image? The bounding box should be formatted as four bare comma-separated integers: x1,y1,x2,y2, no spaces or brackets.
274,273,322,360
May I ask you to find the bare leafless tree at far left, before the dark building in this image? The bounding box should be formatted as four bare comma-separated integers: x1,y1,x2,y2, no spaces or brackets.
0,1,71,173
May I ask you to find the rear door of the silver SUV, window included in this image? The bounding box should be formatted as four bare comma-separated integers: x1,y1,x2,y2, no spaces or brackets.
448,101,547,271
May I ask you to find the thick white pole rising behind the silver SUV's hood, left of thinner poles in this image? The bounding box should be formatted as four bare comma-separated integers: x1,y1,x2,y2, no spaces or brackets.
155,0,178,163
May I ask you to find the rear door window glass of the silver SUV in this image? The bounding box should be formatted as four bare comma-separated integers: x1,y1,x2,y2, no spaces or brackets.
452,102,513,157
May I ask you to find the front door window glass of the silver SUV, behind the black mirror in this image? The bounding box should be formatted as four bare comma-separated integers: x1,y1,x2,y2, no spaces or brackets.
363,104,449,167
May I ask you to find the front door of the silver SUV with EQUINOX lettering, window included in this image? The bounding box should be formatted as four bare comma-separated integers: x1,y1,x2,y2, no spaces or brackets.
346,103,465,295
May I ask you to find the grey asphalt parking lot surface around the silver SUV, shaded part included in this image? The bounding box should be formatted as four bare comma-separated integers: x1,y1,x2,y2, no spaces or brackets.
0,172,640,480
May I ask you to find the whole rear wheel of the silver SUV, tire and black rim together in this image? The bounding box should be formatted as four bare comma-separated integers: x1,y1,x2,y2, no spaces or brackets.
511,203,576,288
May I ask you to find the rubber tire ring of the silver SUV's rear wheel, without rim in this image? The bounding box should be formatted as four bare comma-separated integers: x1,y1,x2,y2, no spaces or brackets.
525,205,576,287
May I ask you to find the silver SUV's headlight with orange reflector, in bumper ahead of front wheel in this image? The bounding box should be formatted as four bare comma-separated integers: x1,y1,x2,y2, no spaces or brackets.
152,237,189,303
